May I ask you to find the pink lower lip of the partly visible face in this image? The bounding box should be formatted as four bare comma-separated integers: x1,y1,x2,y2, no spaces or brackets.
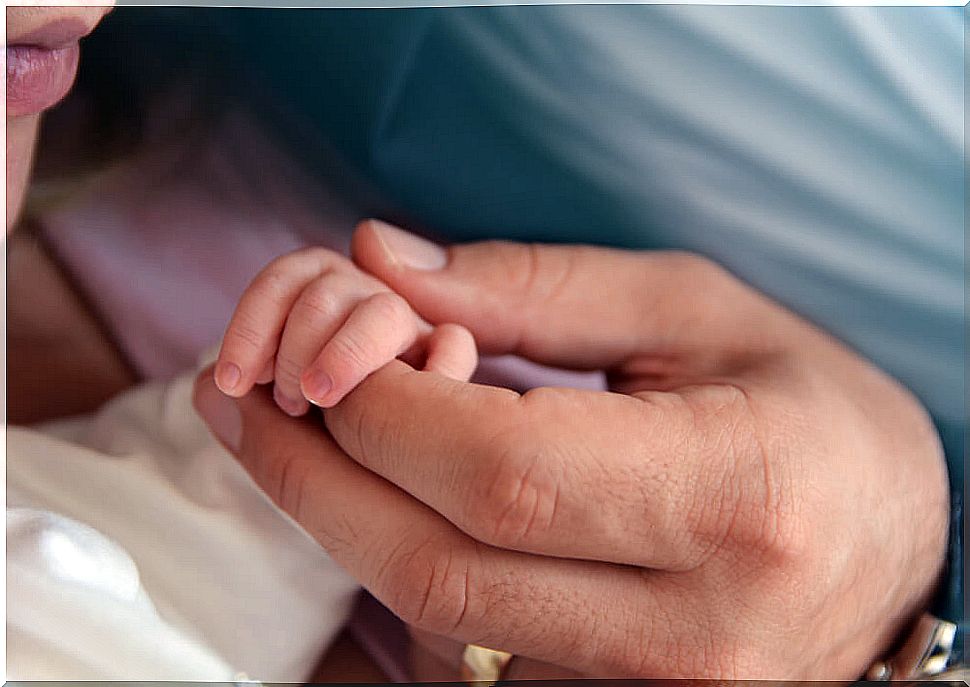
7,43,79,117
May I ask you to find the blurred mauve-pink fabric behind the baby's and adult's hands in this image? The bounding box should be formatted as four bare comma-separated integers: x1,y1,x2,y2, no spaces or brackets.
42,105,603,681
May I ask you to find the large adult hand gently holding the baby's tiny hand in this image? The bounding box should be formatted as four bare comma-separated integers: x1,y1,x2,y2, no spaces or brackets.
197,223,947,679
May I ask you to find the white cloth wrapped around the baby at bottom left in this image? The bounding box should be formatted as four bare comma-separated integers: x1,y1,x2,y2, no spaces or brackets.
6,368,357,682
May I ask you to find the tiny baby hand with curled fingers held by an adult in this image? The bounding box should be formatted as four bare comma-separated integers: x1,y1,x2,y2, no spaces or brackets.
215,248,478,415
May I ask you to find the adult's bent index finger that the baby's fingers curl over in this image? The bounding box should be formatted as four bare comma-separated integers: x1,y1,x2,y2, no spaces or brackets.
325,361,736,570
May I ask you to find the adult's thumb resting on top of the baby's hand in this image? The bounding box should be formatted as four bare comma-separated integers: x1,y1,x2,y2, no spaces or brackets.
352,220,757,369
